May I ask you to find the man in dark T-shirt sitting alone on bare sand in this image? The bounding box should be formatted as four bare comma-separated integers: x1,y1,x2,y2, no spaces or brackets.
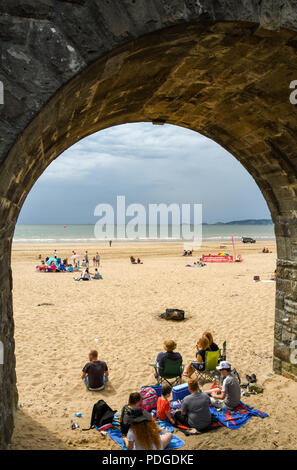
81,349,109,392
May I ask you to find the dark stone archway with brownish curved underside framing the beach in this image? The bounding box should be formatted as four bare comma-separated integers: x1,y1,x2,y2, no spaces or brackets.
0,0,297,447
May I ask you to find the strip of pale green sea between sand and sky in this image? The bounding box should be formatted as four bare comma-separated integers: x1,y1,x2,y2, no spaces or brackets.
13,224,275,243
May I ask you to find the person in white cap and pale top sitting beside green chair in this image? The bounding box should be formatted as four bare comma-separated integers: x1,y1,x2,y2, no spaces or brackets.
207,361,241,410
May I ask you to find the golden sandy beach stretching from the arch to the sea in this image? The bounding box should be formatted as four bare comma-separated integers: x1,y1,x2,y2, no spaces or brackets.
11,242,297,450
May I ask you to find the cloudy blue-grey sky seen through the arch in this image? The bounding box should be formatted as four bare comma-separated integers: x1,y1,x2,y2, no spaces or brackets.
19,123,270,224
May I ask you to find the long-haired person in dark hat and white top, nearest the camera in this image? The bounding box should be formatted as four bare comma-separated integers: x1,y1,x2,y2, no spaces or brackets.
126,408,173,450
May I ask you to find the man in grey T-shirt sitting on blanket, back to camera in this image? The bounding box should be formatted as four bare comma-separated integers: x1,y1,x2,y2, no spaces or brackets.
174,379,211,431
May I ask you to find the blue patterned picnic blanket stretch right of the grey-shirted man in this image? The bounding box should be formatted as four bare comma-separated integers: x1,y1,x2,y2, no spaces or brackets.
209,402,268,429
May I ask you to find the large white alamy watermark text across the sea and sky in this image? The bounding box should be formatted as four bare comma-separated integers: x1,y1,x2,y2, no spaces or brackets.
94,196,202,249
